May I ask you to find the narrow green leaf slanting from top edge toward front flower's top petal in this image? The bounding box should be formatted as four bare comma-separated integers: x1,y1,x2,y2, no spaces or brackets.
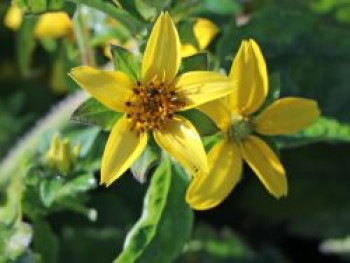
67,0,144,34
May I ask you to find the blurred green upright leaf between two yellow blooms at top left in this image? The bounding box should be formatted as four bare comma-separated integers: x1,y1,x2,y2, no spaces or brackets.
16,16,37,77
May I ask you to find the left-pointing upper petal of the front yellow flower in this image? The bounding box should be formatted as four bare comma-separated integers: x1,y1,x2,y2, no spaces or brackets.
69,66,135,112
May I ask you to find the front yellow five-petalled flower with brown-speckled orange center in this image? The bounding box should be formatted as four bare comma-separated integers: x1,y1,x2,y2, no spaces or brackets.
70,12,233,185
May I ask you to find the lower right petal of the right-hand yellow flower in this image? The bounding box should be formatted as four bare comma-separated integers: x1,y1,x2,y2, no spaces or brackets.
242,135,288,198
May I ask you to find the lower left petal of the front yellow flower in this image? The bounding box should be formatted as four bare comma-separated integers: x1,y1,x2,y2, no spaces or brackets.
101,117,147,186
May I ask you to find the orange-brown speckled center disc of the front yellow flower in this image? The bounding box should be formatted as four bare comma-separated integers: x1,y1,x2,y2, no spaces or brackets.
125,79,185,133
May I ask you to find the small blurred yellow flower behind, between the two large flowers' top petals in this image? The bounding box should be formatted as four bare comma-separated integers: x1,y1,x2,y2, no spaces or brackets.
181,18,219,57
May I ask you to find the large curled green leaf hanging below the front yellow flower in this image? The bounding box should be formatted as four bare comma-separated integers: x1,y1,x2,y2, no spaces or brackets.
114,157,193,263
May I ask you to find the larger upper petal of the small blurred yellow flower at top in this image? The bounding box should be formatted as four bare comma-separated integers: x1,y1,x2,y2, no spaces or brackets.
193,18,219,50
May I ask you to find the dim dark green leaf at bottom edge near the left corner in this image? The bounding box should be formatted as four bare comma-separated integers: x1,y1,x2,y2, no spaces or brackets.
33,219,58,263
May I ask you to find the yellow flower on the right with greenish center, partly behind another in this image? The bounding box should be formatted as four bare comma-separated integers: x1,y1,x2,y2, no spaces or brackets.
186,40,320,210
